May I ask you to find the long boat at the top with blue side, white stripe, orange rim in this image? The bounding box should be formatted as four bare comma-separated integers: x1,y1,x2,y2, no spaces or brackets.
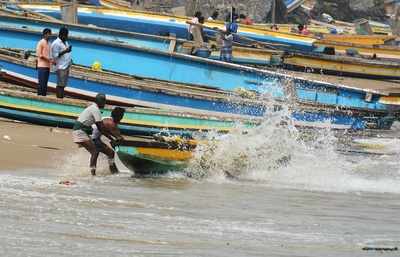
14,4,315,51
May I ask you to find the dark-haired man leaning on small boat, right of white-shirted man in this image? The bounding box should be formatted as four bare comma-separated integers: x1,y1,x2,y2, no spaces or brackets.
92,107,125,175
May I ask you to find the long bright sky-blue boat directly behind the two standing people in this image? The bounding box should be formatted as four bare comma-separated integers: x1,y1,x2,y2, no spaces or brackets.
0,21,290,93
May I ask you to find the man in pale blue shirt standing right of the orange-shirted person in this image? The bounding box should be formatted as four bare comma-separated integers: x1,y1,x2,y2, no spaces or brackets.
51,27,72,98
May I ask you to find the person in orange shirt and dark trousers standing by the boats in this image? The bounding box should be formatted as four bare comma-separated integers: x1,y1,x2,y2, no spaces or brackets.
36,28,53,96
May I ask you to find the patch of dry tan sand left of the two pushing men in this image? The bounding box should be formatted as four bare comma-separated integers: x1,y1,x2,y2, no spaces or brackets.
0,119,78,170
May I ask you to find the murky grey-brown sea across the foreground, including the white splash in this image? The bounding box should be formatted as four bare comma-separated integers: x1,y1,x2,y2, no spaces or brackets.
0,105,400,257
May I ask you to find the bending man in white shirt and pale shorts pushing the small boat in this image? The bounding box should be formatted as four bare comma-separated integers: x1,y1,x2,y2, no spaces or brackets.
72,94,114,176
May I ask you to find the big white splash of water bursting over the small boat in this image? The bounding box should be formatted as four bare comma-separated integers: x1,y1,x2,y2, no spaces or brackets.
187,91,400,193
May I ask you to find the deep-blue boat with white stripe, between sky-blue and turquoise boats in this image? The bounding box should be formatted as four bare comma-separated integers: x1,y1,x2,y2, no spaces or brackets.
0,49,265,118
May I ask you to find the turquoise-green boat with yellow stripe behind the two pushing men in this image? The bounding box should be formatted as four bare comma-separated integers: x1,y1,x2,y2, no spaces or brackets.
0,82,256,137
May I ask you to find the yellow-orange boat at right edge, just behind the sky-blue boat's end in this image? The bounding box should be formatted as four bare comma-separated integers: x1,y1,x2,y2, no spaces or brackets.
283,53,400,79
